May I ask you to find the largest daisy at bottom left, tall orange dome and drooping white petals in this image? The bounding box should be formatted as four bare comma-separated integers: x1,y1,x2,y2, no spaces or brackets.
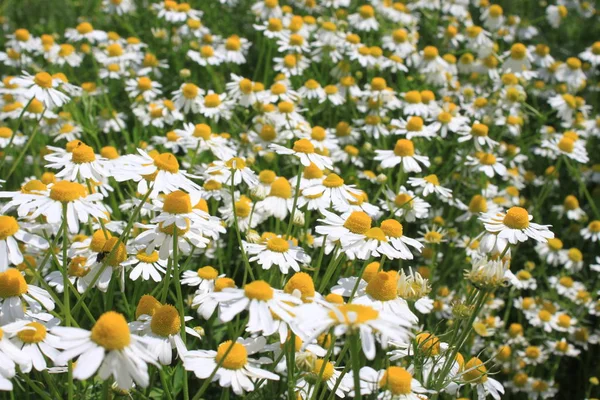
52,311,157,390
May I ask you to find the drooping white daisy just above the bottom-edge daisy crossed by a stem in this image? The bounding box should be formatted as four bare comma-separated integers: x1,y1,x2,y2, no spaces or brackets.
211,280,302,336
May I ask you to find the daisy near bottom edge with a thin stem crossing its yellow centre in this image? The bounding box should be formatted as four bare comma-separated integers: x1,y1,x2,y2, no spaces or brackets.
183,336,279,396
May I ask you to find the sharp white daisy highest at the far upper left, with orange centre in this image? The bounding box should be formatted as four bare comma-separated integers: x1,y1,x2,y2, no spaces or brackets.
14,71,70,109
